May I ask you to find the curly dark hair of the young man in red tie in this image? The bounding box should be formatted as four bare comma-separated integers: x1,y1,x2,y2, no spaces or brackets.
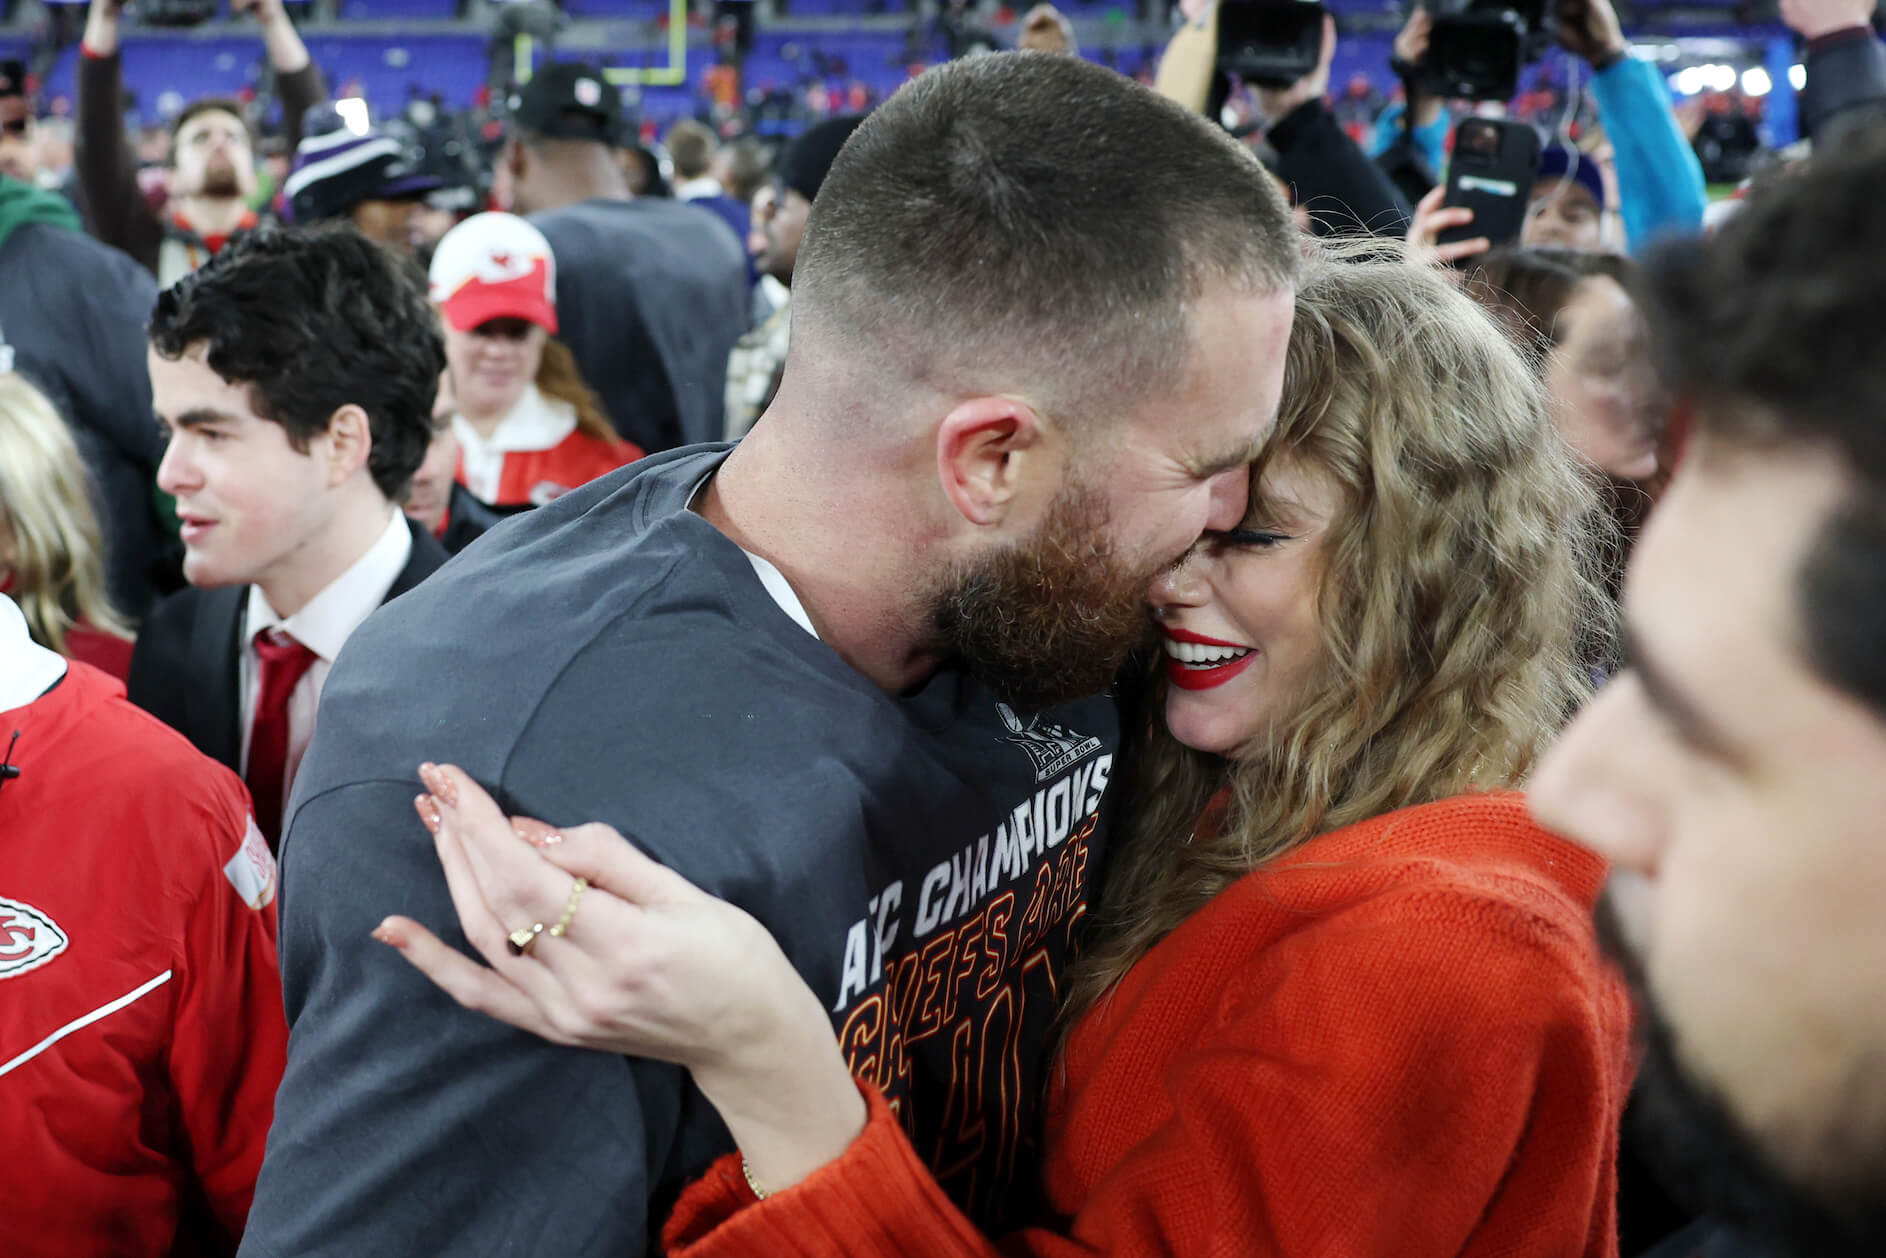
151,223,445,502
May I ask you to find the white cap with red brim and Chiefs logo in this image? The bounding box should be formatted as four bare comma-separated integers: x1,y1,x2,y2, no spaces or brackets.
428,213,556,336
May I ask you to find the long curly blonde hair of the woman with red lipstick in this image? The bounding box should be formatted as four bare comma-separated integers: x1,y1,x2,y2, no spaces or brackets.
1067,243,1613,1015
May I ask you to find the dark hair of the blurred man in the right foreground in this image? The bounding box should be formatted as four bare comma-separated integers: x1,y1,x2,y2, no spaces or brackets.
1639,130,1886,715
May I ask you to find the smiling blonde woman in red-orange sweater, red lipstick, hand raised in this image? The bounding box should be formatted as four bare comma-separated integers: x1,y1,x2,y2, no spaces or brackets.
377,252,1630,1258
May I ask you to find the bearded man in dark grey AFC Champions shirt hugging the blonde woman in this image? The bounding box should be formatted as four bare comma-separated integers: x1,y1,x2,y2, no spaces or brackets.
243,53,1298,1256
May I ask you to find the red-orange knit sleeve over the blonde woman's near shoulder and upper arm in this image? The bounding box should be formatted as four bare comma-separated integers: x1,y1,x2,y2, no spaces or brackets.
1167,886,1630,1258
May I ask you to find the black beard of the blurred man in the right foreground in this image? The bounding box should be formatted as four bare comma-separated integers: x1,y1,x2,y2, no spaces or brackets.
1597,892,1886,1258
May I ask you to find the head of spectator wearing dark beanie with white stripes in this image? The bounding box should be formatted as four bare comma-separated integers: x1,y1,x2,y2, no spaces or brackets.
283,128,443,257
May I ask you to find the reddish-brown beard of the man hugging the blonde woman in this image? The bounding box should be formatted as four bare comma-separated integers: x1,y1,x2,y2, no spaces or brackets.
934,487,1171,709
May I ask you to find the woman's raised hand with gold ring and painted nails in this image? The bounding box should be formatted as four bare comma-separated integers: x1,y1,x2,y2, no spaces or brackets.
373,766,866,1188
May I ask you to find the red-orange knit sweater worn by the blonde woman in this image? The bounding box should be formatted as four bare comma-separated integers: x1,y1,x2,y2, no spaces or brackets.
666,794,1631,1258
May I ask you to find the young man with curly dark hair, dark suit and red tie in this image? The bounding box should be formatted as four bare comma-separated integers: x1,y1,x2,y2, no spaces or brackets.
130,228,445,843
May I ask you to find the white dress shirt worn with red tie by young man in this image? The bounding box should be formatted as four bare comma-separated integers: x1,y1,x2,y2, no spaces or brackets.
240,507,413,803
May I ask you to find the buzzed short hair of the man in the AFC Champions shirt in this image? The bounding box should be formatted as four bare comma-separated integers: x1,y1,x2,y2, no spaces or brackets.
788,53,1299,433
